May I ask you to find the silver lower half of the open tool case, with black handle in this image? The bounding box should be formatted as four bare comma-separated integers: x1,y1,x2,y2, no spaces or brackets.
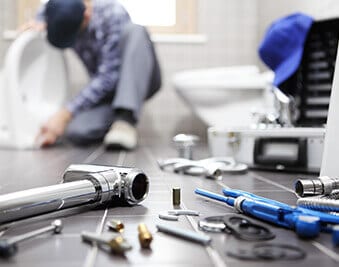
208,127,325,173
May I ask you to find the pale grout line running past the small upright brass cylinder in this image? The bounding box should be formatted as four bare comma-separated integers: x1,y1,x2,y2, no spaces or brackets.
142,146,227,267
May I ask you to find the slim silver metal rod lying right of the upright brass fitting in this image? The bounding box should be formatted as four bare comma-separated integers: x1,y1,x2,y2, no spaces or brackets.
156,224,212,246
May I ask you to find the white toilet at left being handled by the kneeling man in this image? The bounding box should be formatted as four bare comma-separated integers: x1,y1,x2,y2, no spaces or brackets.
0,31,68,149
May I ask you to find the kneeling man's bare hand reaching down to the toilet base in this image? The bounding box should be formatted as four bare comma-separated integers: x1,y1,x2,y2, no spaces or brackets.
36,109,72,147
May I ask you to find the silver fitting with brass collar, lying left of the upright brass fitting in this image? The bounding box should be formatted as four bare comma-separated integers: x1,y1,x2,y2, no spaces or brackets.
81,231,132,254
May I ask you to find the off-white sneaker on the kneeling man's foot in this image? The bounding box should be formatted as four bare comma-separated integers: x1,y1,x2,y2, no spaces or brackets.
103,120,138,150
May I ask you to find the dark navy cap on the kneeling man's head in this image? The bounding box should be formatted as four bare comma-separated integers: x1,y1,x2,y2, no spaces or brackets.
45,0,85,48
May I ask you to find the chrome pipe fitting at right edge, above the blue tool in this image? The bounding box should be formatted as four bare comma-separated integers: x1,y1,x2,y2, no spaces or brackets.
295,176,339,196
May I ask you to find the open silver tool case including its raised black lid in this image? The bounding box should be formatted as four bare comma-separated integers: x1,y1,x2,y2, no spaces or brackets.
208,19,339,172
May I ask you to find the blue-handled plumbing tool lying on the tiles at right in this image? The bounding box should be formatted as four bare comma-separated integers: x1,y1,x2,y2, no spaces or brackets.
195,189,339,243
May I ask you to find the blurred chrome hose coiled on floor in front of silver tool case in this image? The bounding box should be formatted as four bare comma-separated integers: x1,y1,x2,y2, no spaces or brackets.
158,157,247,179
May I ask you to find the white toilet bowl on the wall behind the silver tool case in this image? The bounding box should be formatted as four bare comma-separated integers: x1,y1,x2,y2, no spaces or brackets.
173,66,273,127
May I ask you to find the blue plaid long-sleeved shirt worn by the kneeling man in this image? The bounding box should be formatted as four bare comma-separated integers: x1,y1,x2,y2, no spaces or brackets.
37,0,131,115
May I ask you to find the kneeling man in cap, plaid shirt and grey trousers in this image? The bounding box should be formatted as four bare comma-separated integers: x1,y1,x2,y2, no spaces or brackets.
26,0,161,149
